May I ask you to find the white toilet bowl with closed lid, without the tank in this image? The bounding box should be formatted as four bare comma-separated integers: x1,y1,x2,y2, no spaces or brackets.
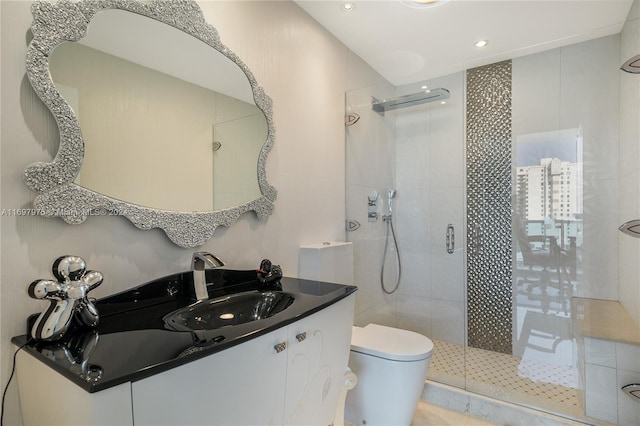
345,324,433,426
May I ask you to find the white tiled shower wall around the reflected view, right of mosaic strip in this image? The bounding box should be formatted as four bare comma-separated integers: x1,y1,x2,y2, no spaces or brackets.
512,36,620,300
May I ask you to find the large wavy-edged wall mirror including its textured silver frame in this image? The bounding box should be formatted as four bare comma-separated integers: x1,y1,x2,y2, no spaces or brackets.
24,0,277,247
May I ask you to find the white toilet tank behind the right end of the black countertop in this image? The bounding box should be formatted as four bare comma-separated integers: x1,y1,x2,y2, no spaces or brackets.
298,241,353,285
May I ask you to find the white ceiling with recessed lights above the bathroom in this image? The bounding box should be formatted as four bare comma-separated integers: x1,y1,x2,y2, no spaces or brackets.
296,0,632,86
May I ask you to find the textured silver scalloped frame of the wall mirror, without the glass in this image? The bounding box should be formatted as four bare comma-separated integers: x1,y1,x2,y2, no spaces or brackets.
24,0,277,247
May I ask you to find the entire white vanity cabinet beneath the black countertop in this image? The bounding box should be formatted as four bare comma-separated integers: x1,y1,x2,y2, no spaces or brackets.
18,295,354,426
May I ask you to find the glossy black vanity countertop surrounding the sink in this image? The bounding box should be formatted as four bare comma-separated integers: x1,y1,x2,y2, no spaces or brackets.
12,269,356,392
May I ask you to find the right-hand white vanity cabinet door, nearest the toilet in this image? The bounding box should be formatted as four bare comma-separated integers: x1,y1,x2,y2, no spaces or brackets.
283,295,355,425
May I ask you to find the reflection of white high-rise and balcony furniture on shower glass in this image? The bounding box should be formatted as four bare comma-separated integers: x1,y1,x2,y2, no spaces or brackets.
512,129,583,415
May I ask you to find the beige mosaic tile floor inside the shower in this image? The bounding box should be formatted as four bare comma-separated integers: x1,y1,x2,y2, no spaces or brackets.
428,340,583,418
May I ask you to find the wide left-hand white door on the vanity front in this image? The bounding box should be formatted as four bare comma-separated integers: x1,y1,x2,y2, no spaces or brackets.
132,327,287,426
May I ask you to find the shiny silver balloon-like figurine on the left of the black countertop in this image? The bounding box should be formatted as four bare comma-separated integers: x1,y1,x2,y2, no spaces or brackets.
28,256,103,340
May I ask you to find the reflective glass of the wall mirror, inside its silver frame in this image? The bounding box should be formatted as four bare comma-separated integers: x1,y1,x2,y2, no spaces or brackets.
49,10,268,211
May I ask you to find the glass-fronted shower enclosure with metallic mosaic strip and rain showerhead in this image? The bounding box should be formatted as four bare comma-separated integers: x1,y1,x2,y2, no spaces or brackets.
345,32,640,424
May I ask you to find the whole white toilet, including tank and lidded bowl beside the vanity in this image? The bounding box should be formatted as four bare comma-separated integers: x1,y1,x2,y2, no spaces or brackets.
298,242,433,426
